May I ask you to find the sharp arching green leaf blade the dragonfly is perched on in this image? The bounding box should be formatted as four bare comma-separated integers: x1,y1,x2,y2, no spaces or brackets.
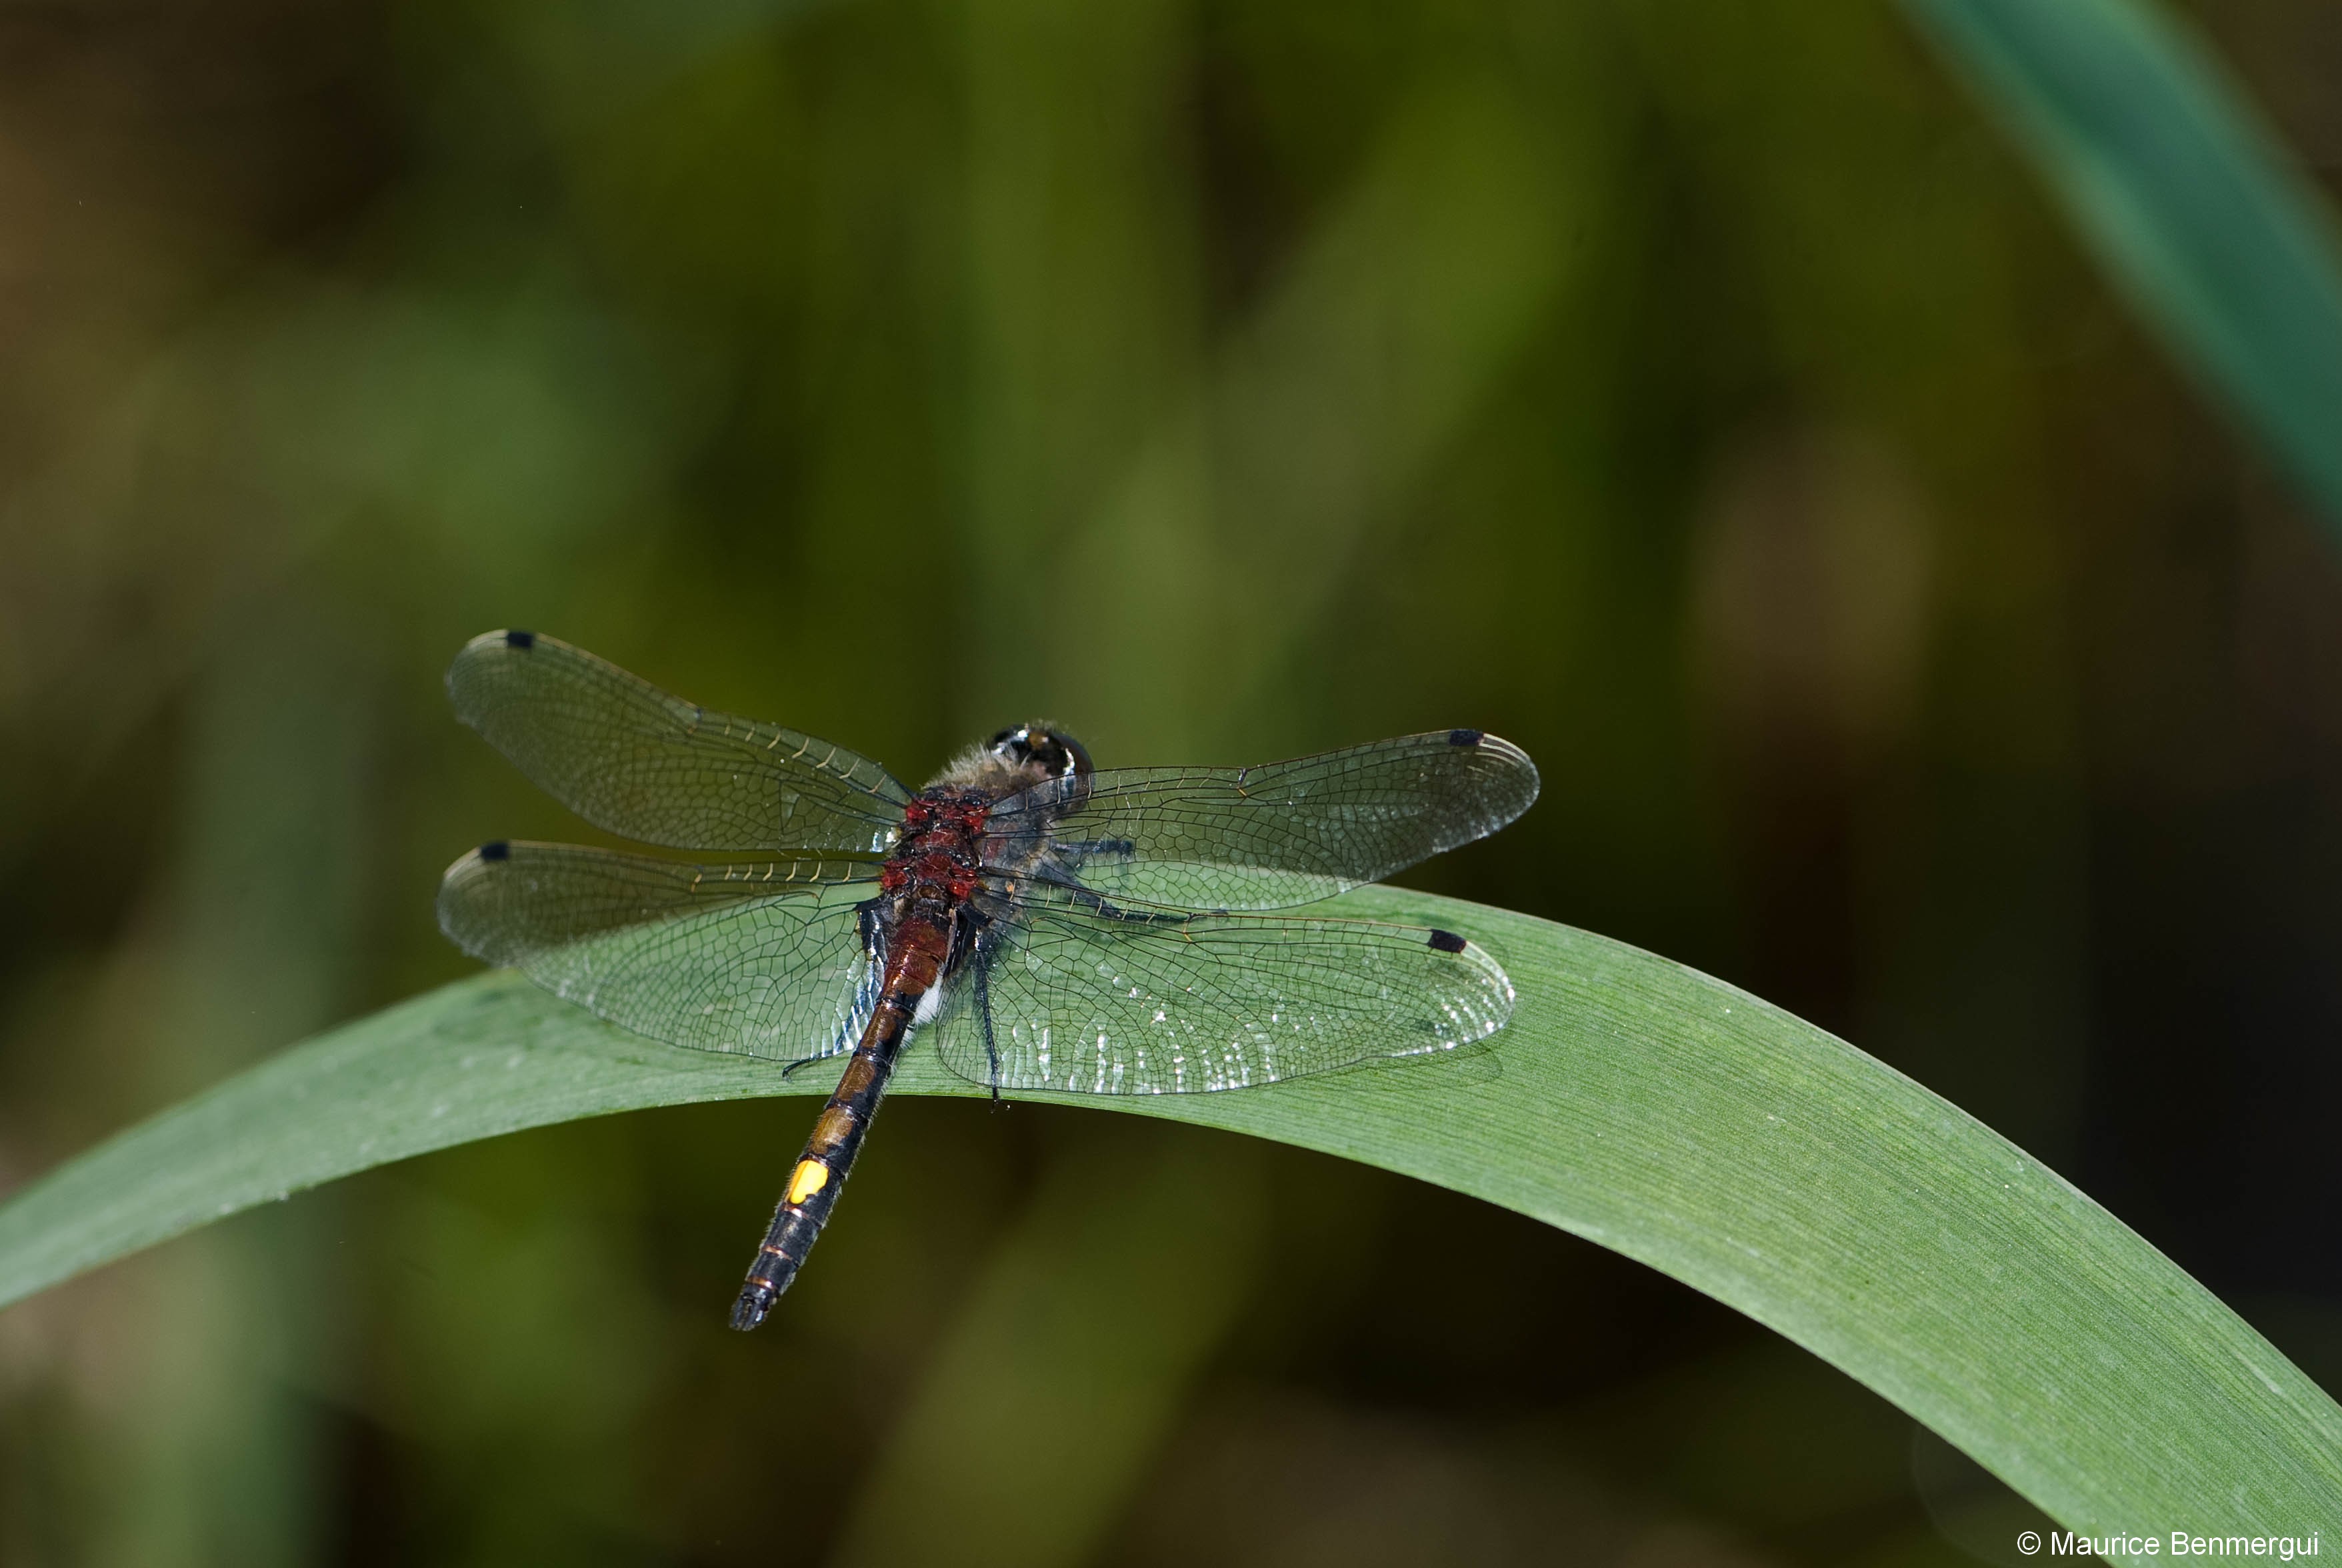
0,887,2342,1535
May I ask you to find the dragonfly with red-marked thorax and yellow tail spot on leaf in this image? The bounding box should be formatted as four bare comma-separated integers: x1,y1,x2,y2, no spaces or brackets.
438,629,1539,1329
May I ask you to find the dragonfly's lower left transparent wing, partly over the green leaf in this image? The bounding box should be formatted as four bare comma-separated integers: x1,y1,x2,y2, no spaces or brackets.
438,843,878,1063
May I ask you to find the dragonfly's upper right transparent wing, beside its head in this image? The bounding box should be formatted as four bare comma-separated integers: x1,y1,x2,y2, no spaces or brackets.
986,730,1537,911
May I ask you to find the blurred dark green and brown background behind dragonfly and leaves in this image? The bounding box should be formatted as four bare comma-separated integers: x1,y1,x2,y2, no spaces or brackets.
0,0,2342,1568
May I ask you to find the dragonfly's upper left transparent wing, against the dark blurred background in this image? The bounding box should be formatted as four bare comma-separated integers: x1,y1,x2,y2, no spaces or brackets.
447,632,911,854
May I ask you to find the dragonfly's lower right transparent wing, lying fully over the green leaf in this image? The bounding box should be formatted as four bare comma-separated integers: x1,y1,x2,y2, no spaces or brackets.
935,906,1513,1095
